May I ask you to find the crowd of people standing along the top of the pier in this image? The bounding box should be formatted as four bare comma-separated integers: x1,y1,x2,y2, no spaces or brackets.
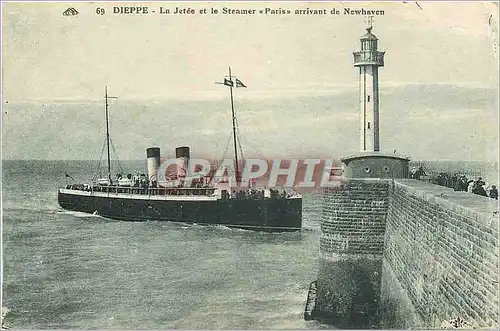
410,166,498,200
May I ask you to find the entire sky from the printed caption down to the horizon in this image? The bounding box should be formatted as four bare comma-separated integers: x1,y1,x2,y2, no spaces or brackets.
2,1,499,161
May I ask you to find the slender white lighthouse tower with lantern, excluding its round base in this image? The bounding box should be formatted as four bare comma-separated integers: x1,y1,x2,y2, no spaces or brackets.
353,26,385,152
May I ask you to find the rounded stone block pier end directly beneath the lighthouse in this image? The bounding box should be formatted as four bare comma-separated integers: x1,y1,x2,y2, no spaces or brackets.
314,179,389,328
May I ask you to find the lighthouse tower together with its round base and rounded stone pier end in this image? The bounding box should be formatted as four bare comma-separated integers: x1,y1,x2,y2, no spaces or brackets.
311,24,410,329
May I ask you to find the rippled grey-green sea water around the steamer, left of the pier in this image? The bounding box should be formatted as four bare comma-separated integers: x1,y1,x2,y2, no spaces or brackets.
2,161,326,329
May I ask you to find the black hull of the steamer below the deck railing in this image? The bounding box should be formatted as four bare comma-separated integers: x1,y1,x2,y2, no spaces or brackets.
58,190,302,232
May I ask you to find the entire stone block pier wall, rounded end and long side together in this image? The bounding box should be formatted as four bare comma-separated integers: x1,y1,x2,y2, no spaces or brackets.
313,179,500,329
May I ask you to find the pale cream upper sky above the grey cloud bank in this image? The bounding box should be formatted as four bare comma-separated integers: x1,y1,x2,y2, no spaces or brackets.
2,3,498,101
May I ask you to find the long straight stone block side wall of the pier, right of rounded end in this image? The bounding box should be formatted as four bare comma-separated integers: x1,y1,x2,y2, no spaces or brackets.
380,180,500,328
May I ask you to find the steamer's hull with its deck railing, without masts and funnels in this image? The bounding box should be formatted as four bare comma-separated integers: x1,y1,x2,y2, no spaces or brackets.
58,184,302,232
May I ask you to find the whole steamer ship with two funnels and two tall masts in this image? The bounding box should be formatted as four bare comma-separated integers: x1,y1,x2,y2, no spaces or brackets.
58,68,302,232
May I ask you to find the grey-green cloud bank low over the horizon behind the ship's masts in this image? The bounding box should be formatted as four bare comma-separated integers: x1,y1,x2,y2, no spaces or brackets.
3,84,498,160
